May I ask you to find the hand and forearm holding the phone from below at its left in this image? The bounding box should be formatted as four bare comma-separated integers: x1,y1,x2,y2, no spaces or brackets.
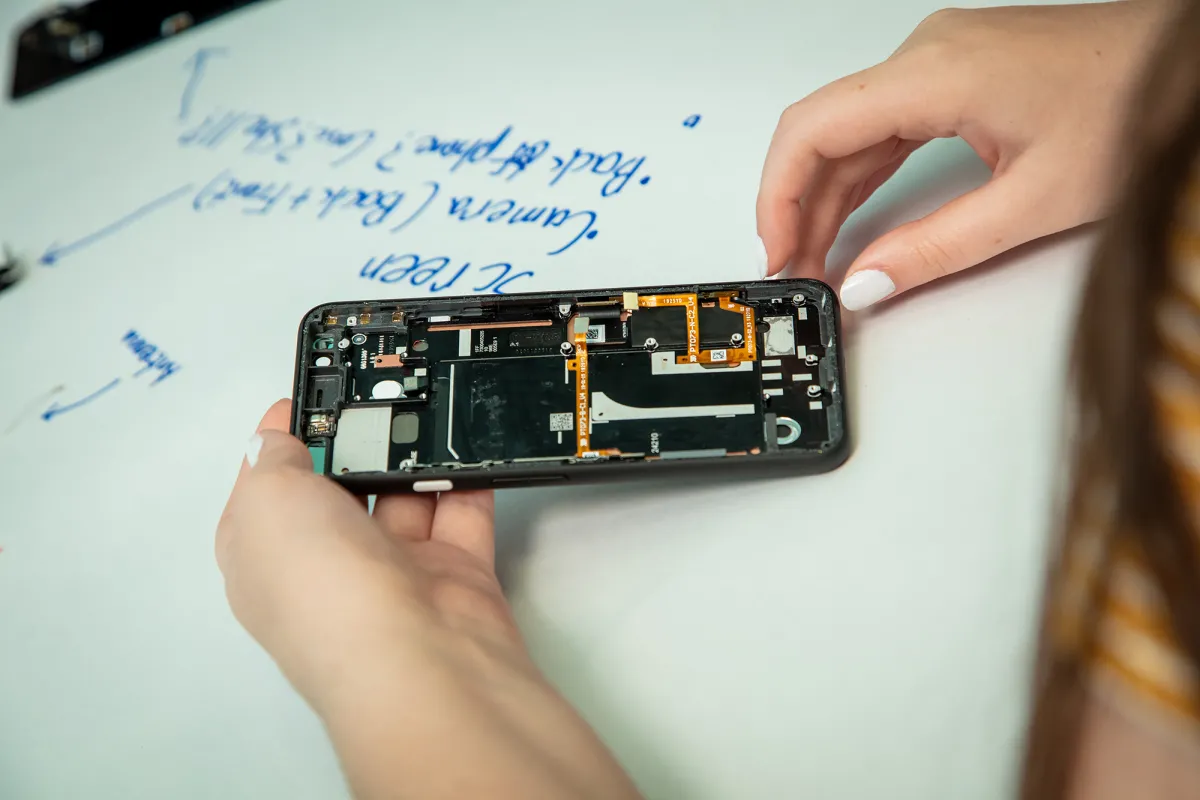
216,401,637,800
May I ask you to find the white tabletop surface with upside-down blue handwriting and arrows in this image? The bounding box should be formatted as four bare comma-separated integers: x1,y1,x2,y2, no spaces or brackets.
0,0,1088,800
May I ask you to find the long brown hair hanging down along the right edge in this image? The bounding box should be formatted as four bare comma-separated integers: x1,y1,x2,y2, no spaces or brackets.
1021,0,1200,800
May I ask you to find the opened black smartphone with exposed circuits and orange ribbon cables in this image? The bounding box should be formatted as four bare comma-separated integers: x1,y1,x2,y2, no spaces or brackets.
292,279,848,494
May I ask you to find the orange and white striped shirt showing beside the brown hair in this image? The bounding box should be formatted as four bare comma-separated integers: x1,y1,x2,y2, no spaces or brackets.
1058,169,1200,739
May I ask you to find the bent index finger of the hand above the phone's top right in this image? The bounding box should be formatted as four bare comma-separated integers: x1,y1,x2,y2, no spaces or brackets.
757,55,961,275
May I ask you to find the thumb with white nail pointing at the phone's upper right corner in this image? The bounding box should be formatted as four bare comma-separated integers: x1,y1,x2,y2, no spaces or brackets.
839,169,1058,311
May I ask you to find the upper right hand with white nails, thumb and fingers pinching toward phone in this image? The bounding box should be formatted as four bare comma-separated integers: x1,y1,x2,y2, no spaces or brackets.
757,0,1169,311
